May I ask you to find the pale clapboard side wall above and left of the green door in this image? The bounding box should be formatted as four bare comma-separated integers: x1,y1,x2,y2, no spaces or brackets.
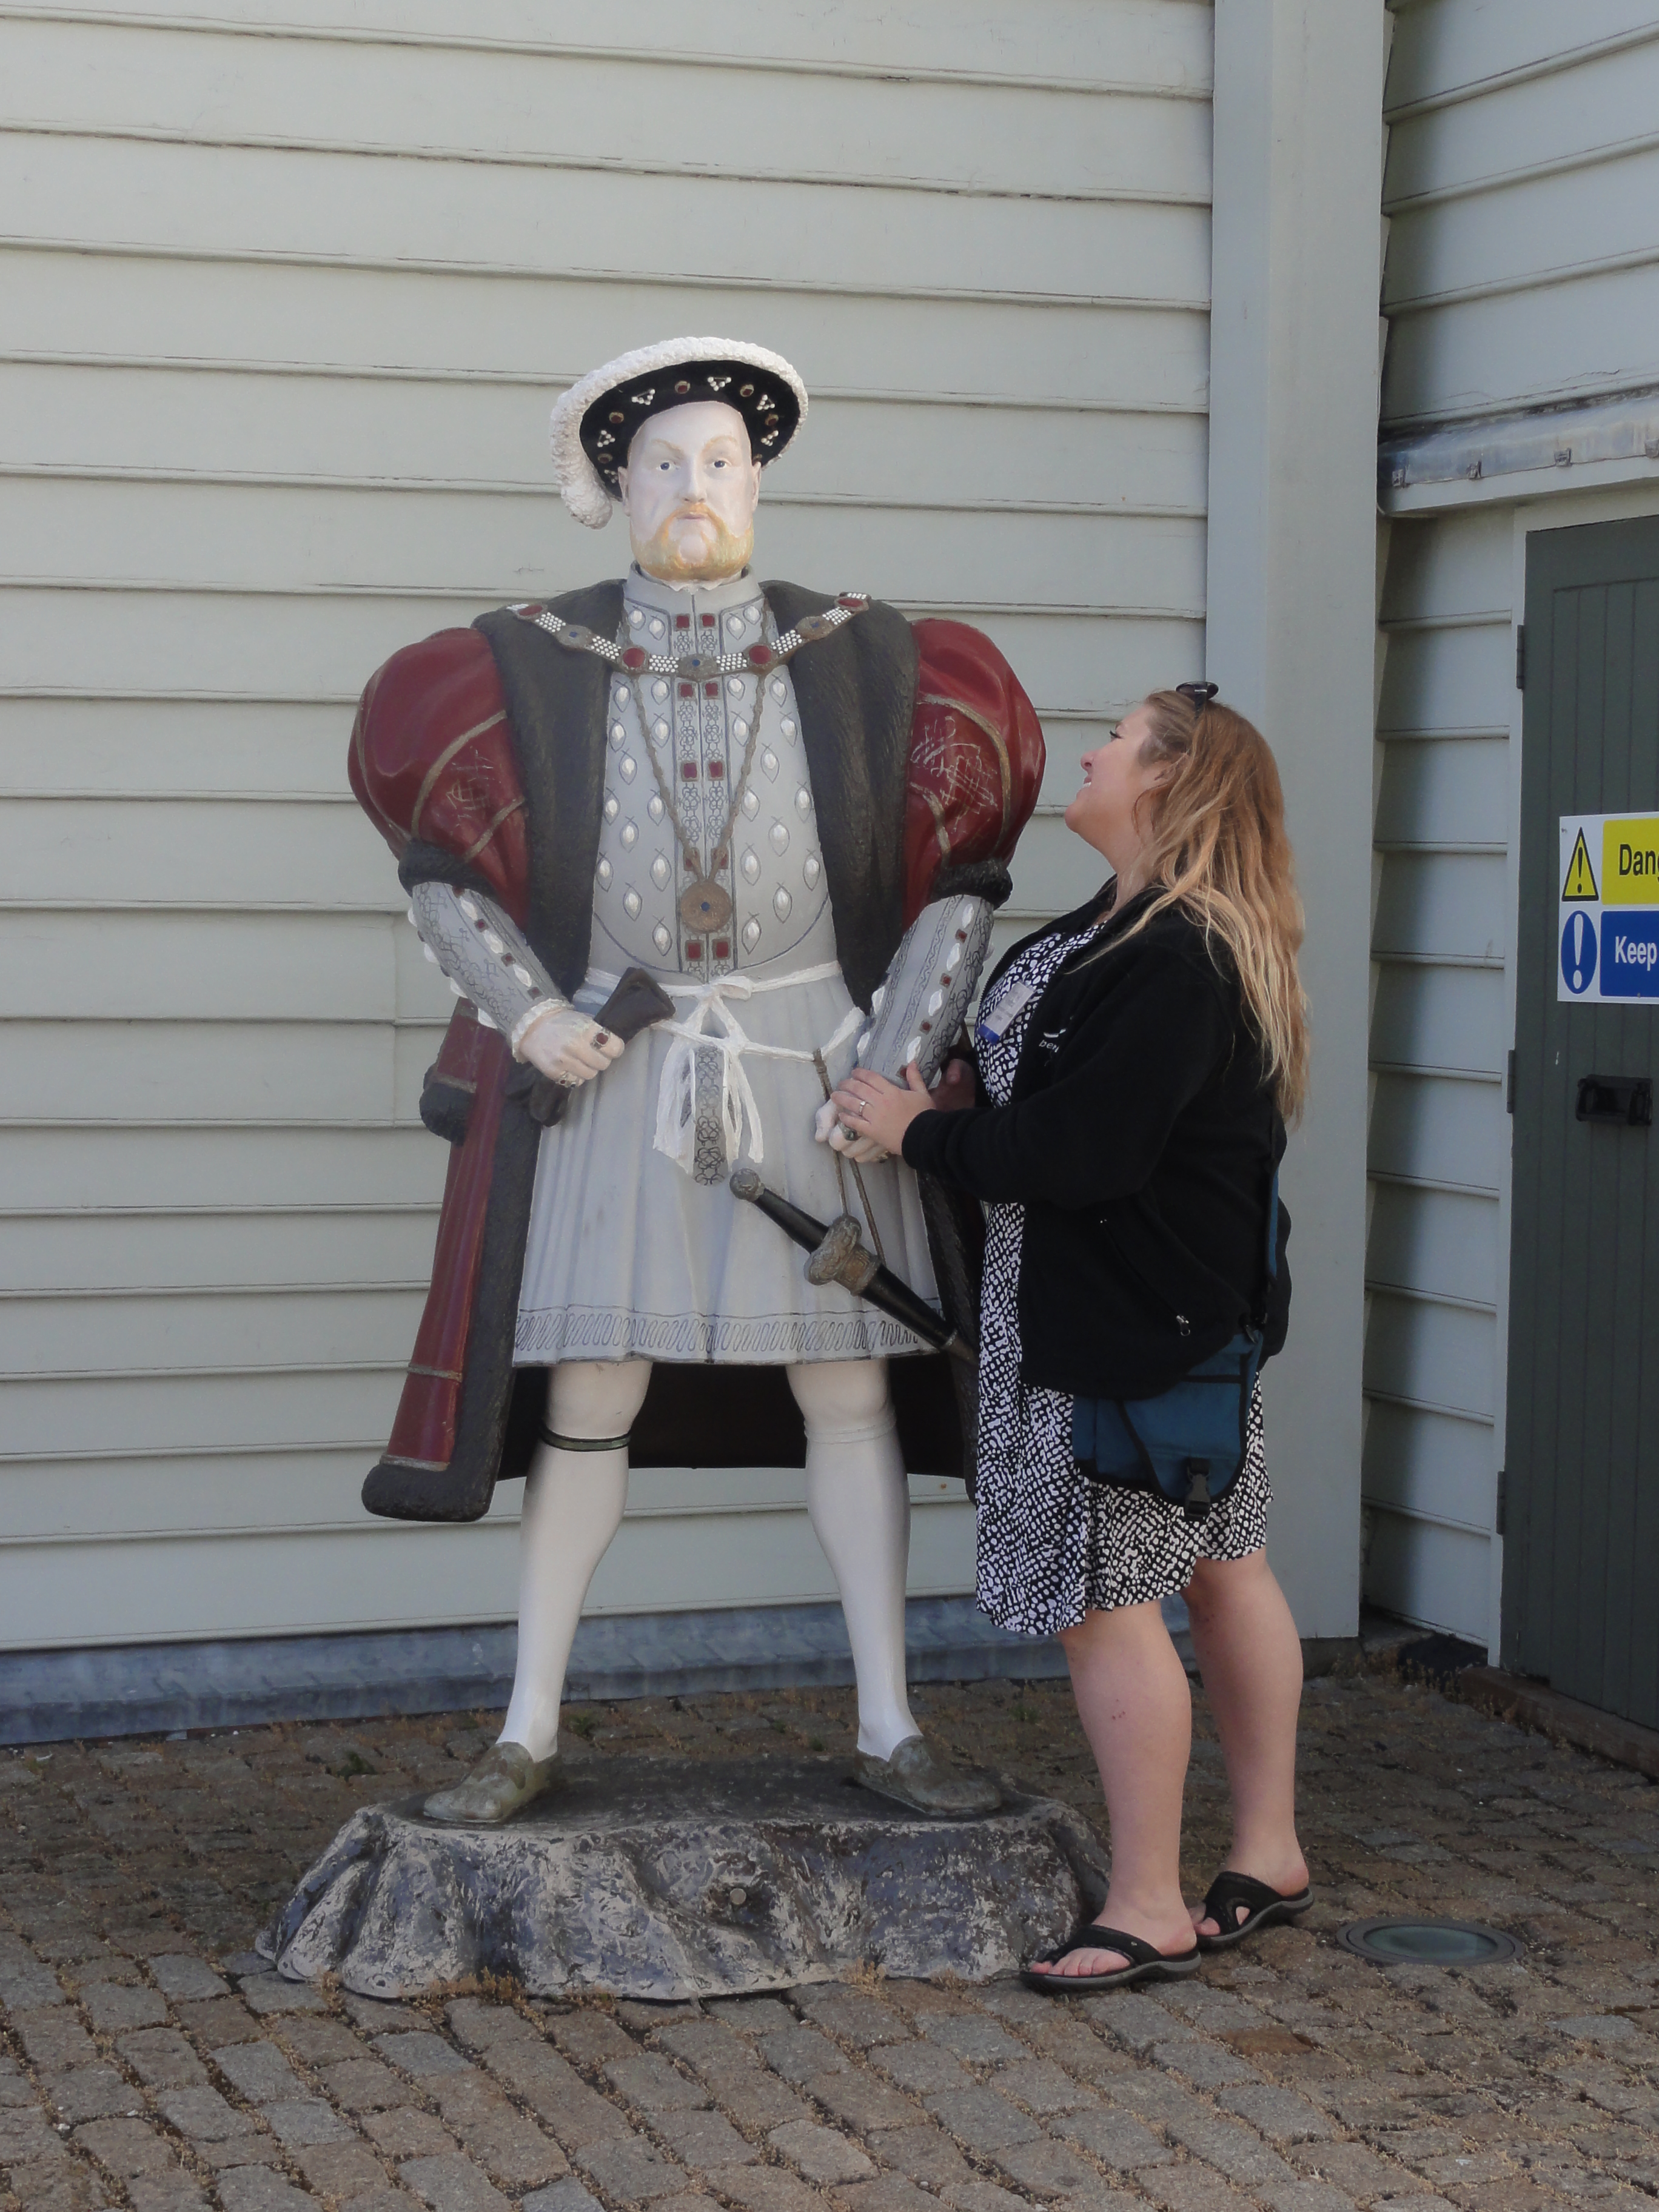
1365,0,1659,1641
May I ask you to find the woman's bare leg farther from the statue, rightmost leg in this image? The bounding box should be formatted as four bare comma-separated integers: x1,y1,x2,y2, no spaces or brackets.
1185,1550,1307,1936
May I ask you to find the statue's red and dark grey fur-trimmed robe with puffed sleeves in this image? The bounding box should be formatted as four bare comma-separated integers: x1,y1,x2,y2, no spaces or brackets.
349,581,1044,1520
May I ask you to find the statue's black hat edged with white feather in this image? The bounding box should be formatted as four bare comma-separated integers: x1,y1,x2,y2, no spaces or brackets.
553,338,808,531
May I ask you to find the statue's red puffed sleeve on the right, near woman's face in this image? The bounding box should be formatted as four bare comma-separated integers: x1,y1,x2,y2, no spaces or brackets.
905,619,1044,929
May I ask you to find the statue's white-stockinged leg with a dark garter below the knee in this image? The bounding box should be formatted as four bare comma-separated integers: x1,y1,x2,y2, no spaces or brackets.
500,1361,651,1758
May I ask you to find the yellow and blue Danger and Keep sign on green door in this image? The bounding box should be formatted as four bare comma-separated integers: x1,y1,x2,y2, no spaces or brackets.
1555,814,1659,1004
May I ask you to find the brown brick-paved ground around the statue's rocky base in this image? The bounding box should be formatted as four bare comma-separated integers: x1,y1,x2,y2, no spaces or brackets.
0,1675,1659,2212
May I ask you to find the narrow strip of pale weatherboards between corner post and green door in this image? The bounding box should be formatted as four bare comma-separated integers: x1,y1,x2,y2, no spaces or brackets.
1362,511,1515,1641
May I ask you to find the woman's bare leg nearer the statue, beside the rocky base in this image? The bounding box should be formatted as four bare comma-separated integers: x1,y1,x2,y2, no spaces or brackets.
1037,1604,1192,1973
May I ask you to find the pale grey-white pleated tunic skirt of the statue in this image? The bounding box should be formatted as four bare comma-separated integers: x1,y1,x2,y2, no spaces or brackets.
513,947,938,1367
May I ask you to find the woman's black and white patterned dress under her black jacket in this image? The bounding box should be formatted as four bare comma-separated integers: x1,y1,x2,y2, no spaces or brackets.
976,907,1272,1637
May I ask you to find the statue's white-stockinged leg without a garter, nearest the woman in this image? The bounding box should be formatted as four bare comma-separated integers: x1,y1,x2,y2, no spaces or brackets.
789,1361,920,1758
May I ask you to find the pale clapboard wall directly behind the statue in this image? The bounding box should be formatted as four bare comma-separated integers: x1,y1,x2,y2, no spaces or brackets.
0,0,1212,1648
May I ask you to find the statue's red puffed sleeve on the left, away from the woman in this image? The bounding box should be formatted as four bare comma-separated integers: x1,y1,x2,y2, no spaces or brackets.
347,631,529,925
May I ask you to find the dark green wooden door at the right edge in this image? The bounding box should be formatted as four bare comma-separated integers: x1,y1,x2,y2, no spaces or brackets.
1502,515,1659,1728
